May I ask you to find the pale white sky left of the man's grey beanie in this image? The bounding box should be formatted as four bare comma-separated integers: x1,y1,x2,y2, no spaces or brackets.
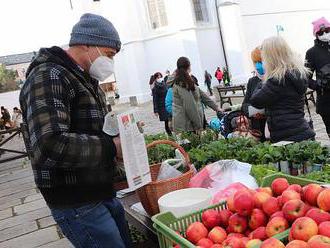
0,0,81,56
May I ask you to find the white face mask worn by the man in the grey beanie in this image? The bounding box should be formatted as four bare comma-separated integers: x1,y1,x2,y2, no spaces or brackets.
89,47,114,81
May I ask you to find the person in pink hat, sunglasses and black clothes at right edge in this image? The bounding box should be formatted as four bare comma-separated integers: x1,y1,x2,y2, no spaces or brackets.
306,17,330,137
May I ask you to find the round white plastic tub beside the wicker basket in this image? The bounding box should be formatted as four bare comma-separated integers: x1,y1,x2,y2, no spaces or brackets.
158,188,212,218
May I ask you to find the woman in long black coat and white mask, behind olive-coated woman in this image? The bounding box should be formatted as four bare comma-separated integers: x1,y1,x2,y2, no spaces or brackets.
152,72,172,136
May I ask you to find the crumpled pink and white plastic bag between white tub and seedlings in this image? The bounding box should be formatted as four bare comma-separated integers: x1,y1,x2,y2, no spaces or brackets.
189,160,258,202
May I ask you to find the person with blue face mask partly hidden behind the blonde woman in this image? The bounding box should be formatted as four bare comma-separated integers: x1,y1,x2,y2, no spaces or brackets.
242,47,266,141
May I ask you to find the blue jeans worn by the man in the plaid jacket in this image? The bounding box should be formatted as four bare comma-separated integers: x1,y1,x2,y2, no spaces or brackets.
51,198,131,248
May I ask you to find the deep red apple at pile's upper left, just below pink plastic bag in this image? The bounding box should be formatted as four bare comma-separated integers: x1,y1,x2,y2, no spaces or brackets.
234,191,254,216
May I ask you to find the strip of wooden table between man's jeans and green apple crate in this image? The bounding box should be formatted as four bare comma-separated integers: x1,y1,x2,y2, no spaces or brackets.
119,193,159,248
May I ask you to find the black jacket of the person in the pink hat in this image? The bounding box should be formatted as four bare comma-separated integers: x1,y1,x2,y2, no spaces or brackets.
306,39,330,115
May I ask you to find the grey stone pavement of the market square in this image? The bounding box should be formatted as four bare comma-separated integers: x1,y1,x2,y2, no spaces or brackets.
0,99,330,248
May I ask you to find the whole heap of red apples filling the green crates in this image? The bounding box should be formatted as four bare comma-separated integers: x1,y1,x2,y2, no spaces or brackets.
174,178,330,248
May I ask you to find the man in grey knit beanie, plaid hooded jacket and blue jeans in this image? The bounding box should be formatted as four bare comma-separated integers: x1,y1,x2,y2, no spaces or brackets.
20,14,130,248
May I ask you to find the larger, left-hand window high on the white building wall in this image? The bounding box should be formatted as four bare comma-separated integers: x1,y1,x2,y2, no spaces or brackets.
147,0,168,29
